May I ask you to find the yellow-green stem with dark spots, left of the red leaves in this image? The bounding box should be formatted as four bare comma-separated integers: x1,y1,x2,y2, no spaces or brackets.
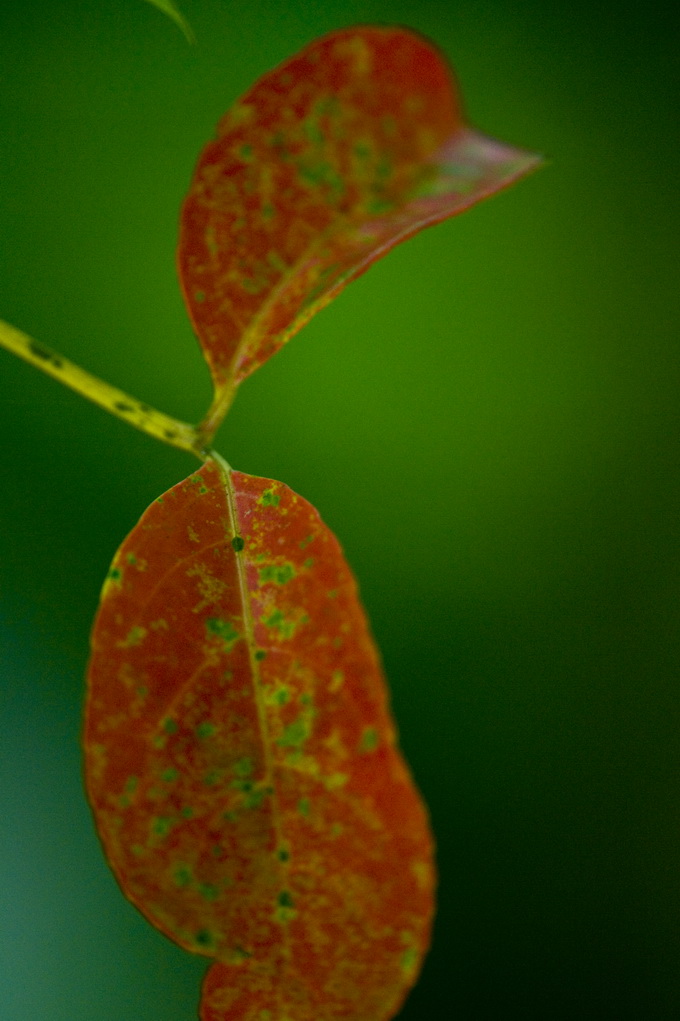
0,320,206,460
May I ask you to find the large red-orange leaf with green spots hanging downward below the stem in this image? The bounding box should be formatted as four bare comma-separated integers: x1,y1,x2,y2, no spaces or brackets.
85,459,434,1021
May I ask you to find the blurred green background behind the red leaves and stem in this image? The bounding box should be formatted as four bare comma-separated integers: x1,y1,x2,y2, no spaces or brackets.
0,0,680,1021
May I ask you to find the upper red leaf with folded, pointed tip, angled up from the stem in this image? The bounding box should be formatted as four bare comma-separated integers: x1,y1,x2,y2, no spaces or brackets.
178,28,540,424
